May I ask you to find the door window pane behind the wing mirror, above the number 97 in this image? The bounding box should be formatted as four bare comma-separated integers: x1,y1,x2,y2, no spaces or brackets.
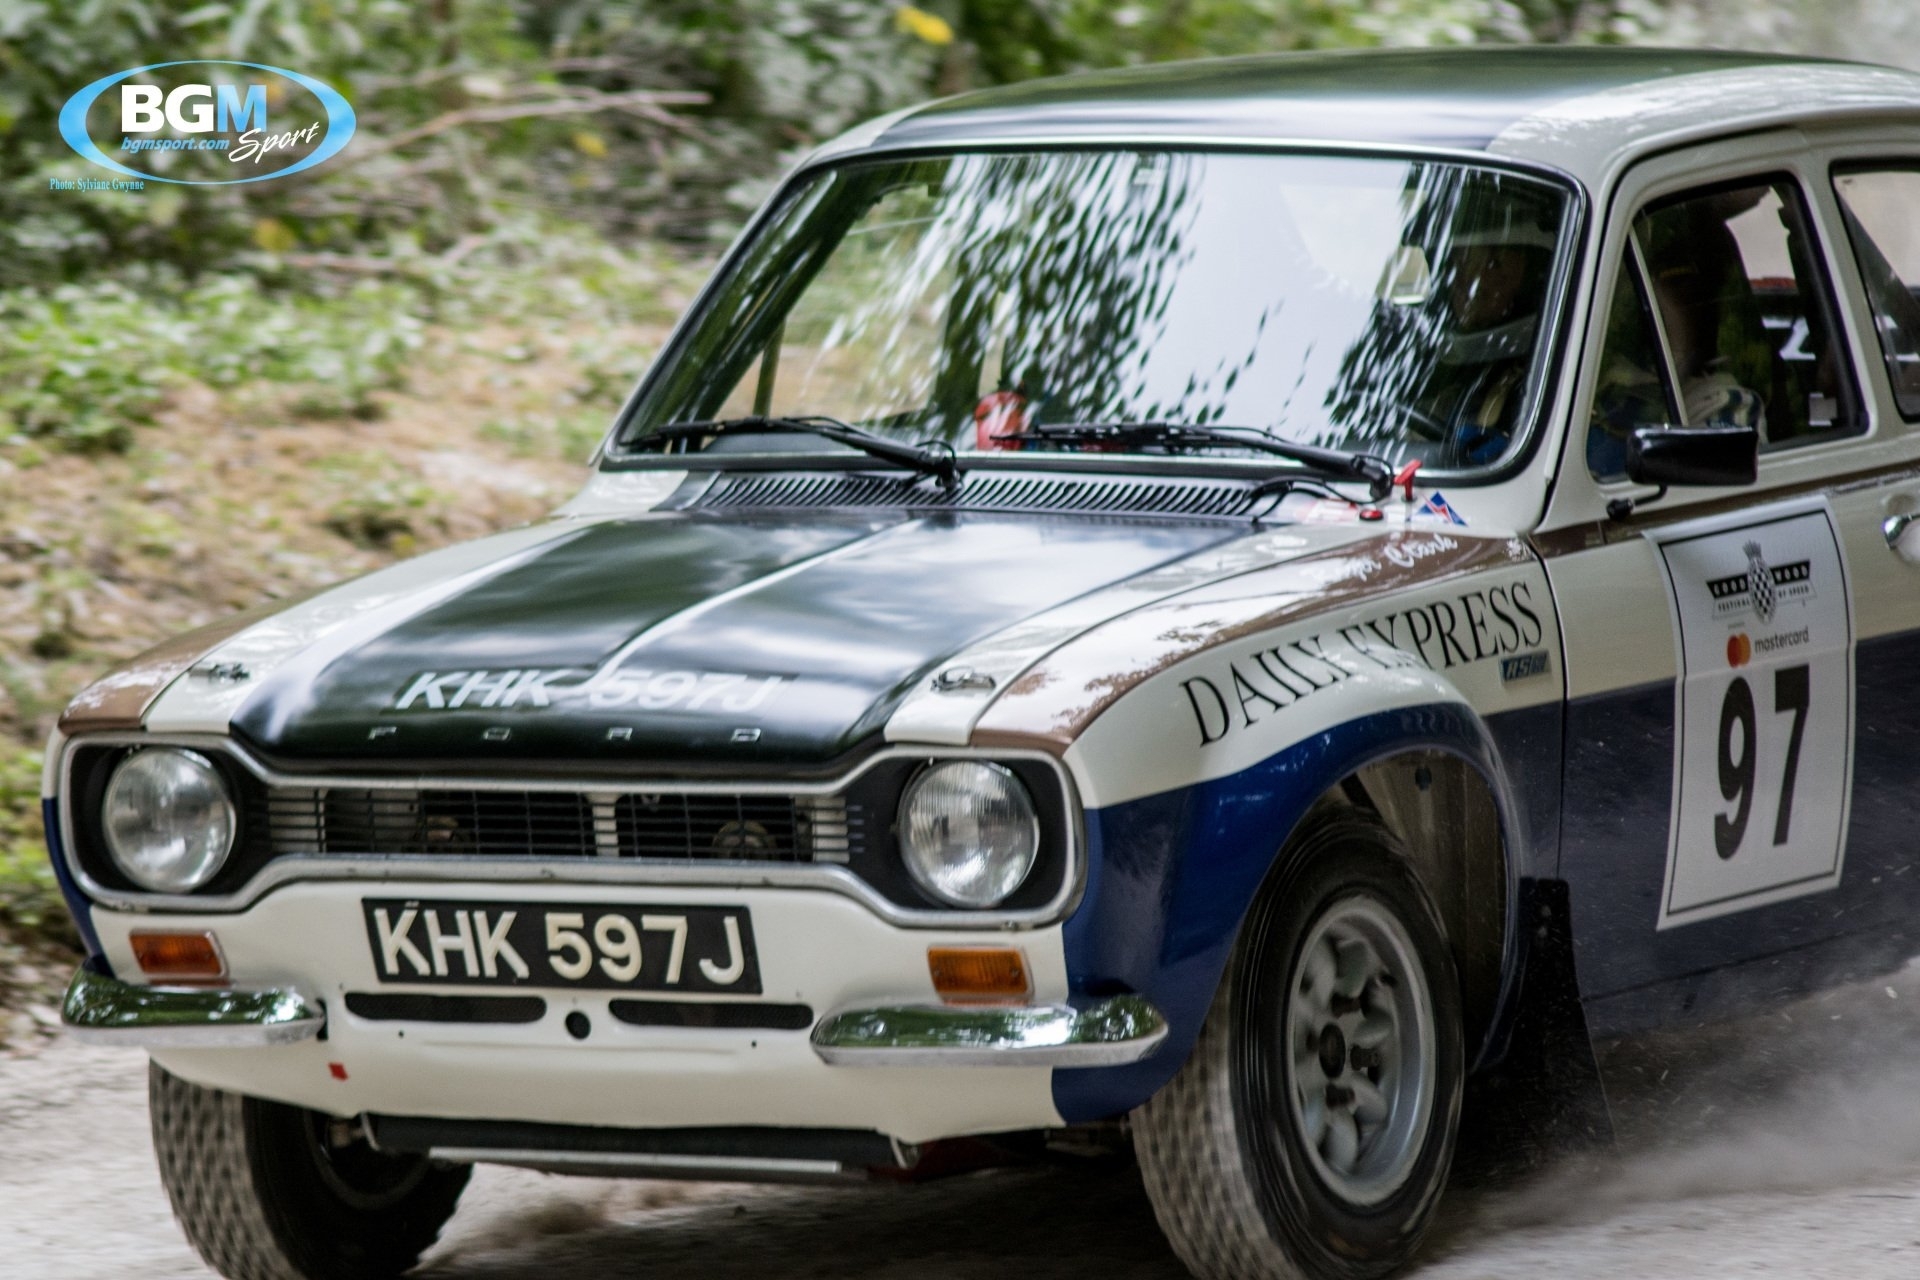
1634,177,1864,449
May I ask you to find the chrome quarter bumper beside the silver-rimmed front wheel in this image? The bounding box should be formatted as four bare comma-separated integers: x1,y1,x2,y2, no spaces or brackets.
814,996,1167,1067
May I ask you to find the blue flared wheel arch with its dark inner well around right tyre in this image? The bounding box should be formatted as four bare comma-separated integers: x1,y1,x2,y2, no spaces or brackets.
1054,694,1528,1121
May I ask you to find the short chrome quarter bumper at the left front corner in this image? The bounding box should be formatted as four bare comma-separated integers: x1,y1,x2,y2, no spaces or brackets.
60,965,326,1050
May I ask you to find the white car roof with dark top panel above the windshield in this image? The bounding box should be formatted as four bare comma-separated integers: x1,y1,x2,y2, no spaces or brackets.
826,46,1920,178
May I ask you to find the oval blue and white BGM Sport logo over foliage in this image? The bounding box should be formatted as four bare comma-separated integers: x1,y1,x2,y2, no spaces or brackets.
60,59,355,186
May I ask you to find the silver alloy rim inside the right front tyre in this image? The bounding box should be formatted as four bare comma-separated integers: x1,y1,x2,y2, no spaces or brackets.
1286,892,1434,1205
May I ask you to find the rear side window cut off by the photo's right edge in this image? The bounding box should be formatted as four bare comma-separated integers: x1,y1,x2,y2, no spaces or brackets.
1834,167,1920,420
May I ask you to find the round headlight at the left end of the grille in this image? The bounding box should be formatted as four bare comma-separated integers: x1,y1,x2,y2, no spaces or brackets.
100,747,238,892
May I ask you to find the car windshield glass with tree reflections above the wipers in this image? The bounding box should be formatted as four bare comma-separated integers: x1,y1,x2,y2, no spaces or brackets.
622,150,1571,468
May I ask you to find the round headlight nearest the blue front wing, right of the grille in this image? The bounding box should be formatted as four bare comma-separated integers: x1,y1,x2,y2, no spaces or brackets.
900,760,1041,908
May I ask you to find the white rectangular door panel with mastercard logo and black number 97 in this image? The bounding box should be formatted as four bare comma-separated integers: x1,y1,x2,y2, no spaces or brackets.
1649,499,1853,929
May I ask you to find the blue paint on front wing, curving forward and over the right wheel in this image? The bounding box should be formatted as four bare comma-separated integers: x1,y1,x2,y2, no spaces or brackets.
1054,704,1512,1121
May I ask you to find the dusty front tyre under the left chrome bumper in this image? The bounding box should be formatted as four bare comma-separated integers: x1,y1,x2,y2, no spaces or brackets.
148,1063,472,1280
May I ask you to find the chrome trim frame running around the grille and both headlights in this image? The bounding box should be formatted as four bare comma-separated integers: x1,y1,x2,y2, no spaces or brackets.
60,733,1087,929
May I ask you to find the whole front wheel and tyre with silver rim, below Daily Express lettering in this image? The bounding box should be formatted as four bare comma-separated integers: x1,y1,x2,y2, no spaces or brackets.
1133,812,1463,1280
